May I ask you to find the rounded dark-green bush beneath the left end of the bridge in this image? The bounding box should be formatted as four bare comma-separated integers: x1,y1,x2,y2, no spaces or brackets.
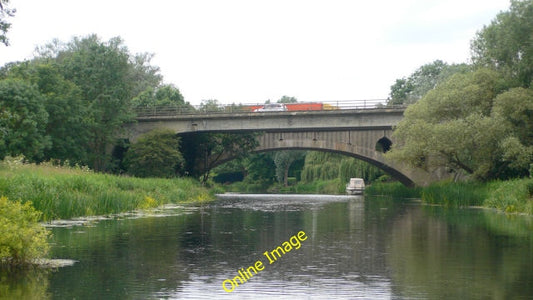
125,130,185,178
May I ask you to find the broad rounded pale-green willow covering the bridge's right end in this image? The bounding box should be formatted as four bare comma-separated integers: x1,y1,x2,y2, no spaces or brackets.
387,69,532,180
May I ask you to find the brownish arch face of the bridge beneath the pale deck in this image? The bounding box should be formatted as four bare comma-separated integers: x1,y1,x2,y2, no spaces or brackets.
197,129,446,186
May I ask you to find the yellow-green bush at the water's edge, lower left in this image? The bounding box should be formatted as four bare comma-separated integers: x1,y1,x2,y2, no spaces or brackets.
0,196,49,266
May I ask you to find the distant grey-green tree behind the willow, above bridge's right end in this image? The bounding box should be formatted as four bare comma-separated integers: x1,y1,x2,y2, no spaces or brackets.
388,60,469,105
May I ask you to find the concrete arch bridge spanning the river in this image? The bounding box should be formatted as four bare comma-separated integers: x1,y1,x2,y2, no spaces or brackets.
129,108,445,186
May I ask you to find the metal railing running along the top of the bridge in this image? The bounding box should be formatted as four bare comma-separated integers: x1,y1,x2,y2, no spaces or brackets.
135,99,404,117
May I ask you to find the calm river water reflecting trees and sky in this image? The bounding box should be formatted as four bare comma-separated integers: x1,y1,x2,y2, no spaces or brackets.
0,195,533,299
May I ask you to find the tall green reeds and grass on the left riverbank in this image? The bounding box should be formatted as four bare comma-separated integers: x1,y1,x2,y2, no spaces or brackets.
0,161,212,221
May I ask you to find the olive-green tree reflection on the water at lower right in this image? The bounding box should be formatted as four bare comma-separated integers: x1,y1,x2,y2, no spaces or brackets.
389,207,533,299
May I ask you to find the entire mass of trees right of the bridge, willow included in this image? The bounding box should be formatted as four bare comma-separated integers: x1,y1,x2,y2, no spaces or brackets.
387,0,533,180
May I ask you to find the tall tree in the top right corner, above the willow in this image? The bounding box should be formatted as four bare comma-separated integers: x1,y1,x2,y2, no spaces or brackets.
471,0,533,88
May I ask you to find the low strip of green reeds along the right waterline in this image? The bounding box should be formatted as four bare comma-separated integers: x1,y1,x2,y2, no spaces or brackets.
365,178,533,215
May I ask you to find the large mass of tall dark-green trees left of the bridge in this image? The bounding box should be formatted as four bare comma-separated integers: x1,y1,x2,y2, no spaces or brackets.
0,35,161,171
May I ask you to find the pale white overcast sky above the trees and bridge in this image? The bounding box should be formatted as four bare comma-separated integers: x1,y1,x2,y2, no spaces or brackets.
0,0,510,104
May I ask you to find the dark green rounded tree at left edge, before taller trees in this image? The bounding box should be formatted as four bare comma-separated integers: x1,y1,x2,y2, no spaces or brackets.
0,79,50,161
